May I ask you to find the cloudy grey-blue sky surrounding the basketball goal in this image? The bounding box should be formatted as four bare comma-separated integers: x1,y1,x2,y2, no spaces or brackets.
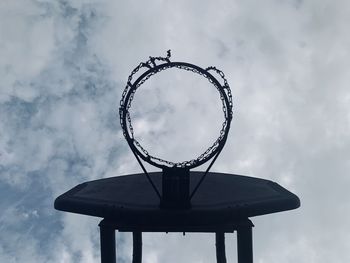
0,0,350,263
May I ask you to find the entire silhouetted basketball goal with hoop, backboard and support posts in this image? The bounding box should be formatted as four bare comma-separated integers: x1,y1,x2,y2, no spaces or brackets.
55,51,300,263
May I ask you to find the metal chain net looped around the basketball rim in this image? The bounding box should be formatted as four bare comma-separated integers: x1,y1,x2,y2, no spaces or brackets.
119,50,233,168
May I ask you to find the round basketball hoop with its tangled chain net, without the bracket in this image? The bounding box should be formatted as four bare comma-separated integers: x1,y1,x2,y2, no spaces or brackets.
119,50,232,169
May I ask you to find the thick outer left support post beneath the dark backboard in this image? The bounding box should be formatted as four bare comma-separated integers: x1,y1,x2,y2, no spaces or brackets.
99,220,116,263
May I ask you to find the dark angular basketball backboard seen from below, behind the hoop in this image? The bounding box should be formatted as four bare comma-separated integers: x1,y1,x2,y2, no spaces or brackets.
55,172,300,232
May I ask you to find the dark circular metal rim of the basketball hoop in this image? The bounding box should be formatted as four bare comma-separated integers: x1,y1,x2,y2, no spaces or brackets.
119,61,232,169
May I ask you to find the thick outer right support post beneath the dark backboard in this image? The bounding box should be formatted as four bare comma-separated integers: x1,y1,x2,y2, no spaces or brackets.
237,220,253,263
